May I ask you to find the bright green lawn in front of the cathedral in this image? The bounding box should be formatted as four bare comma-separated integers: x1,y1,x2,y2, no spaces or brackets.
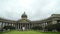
0,30,60,34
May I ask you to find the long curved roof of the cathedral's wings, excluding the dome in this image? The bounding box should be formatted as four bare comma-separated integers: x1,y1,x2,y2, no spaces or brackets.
0,14,60,23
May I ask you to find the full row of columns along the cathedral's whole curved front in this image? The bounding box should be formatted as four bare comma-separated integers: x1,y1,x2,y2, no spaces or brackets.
0,21,57,29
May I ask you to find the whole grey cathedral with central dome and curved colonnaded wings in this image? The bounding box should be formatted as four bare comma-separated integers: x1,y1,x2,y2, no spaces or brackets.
0,12,60,30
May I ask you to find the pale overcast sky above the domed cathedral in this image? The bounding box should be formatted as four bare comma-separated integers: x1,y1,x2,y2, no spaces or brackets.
0,0,60,20
